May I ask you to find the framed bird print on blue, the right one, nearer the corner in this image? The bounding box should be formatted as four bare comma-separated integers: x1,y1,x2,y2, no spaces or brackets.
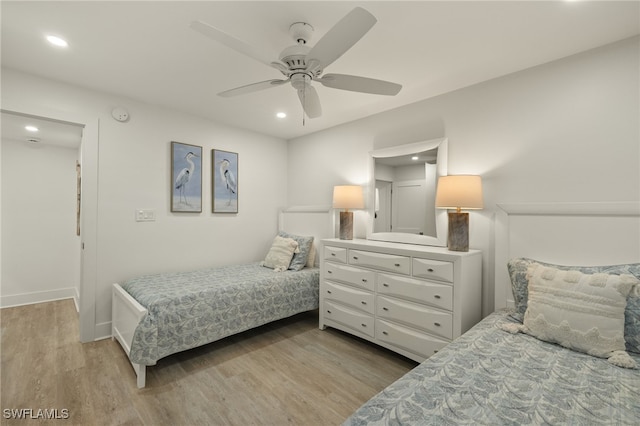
211,149,238,213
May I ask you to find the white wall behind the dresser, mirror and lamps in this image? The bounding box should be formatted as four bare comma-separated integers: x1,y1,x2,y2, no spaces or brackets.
289,37,640,314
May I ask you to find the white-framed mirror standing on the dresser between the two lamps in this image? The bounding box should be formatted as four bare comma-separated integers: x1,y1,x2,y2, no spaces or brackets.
367,138,447,247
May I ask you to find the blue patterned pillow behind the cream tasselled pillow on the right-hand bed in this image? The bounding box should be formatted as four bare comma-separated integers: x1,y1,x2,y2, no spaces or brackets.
507,258,640,353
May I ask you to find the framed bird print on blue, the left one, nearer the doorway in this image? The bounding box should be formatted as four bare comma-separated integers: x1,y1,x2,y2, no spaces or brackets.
171,142,202,213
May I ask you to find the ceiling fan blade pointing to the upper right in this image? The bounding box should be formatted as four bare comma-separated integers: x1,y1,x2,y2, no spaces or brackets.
307,7,377,68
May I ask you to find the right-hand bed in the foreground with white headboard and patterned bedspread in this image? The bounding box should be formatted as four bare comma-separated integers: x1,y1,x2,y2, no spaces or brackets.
344,202,640,425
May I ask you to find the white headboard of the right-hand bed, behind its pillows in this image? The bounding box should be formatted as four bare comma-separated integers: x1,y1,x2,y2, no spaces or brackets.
494,201,640,309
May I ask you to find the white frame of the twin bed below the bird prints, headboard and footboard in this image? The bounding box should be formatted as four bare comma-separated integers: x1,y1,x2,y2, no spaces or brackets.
111,206,335,388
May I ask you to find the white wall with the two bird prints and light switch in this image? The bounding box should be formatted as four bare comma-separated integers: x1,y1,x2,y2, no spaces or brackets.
2,69,287,337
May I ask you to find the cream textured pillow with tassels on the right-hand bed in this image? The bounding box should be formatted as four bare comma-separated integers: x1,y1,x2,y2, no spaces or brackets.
522,263,640,368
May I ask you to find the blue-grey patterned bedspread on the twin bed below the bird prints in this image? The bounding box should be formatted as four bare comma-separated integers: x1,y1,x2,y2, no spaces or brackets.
122,263,320,365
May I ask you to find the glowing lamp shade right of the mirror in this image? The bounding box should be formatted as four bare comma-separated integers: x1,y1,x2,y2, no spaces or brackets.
436,175,483,209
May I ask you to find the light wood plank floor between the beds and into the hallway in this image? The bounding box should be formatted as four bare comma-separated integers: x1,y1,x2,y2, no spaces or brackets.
0,300,416,425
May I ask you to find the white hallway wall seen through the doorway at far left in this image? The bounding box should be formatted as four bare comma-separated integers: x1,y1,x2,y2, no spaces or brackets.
0,139,80,307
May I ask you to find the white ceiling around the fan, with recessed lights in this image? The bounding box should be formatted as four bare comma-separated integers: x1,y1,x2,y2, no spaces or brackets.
1,0,640,139
